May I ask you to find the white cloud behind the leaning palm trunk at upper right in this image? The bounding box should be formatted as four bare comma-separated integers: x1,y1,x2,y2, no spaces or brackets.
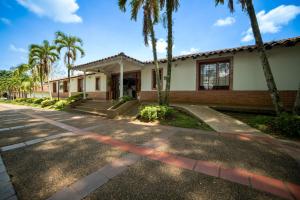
242,5,300,42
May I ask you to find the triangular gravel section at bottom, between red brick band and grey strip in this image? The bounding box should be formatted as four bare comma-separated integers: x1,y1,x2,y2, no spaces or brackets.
85,160,279,200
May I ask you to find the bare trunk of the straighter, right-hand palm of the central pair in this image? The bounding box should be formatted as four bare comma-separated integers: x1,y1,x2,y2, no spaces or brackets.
164,0,173,105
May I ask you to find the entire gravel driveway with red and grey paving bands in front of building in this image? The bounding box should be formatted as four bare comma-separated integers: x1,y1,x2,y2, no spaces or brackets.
0,104,300,200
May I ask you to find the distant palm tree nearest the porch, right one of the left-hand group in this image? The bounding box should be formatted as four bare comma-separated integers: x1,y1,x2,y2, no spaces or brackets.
55,31,85,97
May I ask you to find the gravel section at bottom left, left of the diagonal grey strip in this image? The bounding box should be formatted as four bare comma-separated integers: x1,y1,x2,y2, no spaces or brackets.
2,137,123,200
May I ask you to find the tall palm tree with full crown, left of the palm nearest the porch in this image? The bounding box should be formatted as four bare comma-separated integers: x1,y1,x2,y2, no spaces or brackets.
30,40,59,99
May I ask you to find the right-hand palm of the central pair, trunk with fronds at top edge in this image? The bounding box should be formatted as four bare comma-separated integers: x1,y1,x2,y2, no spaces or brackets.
160,0,179,105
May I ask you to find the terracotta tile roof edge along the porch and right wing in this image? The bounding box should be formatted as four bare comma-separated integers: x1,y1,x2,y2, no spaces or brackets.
74,36,300,70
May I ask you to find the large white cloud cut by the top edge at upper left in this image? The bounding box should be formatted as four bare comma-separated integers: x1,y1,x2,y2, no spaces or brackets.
17,0,82,23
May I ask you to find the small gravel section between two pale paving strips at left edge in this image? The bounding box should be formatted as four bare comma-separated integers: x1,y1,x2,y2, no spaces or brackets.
0,124,67,146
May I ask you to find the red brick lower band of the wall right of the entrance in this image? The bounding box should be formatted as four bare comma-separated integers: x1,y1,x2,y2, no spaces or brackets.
141,91,296,108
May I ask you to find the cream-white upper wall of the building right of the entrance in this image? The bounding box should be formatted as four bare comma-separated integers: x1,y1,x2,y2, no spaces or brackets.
141,45,300,91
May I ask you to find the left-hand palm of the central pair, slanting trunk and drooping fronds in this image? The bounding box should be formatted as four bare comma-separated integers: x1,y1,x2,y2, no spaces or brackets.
119,0,163,105
